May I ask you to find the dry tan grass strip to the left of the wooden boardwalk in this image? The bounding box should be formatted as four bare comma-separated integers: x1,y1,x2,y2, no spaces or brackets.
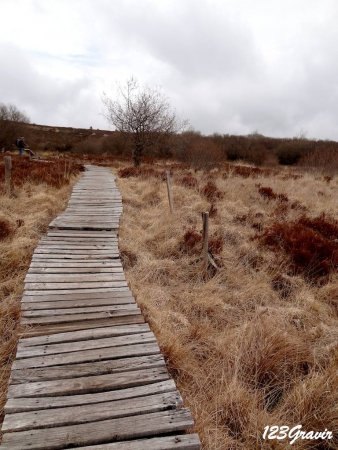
0,156,78,428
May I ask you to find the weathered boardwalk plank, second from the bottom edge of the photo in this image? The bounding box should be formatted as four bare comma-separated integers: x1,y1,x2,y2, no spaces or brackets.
3,409,193,450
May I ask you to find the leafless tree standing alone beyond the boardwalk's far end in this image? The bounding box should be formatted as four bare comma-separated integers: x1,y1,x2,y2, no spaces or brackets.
103,78,185,166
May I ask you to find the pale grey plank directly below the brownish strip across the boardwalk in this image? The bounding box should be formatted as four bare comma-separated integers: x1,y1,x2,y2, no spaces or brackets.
19,324,150,347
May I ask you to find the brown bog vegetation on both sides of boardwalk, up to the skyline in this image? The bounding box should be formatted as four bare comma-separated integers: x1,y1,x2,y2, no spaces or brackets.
0,117,338,450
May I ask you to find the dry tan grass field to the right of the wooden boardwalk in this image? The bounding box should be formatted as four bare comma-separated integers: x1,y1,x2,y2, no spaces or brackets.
118,165,338,450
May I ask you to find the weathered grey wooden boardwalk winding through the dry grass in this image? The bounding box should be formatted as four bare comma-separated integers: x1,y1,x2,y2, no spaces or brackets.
1,166,200,450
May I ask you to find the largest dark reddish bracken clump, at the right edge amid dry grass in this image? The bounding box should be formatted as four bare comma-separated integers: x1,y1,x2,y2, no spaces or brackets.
261,217,338,280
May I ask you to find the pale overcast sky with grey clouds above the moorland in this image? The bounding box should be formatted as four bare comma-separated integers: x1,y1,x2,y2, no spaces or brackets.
0,0,338,140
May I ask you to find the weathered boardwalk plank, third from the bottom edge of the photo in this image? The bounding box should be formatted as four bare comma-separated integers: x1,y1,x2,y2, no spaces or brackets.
2,391,182,432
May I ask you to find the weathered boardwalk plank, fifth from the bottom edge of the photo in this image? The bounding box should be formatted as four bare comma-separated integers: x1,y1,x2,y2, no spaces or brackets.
7,367,169,398
